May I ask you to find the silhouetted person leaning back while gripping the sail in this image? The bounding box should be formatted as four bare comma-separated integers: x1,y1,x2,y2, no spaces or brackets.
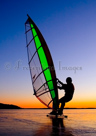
57,77,75,115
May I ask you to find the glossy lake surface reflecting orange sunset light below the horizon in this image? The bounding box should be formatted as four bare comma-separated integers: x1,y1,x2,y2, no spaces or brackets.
0,109,96,136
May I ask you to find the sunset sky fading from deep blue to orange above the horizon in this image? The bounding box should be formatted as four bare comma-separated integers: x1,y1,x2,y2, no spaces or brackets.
0,0,96,108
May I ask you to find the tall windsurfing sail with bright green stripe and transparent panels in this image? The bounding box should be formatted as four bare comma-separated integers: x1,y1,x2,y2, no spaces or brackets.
25,15,58,109
